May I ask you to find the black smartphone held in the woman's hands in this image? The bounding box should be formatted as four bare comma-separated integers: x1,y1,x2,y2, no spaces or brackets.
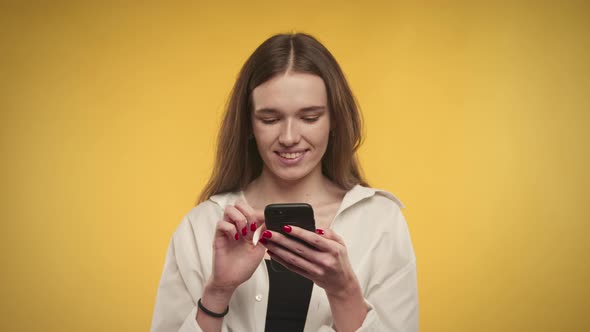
264,203,315,272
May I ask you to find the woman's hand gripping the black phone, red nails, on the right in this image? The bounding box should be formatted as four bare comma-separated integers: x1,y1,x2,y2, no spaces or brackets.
262,226,359,297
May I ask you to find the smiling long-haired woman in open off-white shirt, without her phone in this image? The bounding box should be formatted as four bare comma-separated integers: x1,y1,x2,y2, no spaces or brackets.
152,34,418,331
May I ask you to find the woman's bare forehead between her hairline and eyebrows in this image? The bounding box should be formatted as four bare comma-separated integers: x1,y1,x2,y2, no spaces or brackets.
252,73,328,111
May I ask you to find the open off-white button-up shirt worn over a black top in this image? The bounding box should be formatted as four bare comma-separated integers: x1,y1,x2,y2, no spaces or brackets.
151,185,418,332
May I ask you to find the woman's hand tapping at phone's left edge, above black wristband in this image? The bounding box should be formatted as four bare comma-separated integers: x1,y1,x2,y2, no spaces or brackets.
208,200,266,290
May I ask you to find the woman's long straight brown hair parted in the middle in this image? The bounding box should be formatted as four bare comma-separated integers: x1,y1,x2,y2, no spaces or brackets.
197,33,367,203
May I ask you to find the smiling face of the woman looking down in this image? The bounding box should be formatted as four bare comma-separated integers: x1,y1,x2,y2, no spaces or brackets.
252,73,330,182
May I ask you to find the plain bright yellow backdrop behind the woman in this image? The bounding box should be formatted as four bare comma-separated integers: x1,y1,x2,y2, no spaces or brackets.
0,1,590,331
